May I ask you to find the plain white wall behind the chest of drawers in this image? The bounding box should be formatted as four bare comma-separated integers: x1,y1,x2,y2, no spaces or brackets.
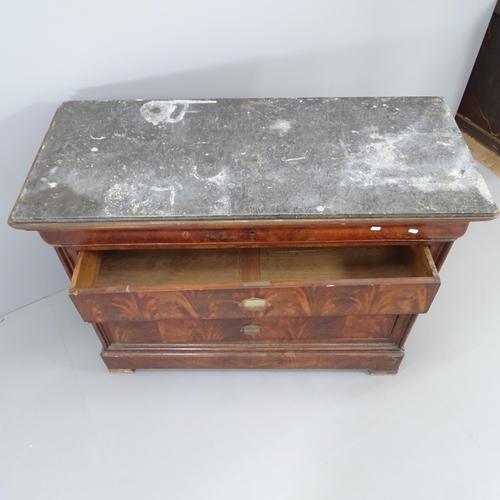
0,0,495,314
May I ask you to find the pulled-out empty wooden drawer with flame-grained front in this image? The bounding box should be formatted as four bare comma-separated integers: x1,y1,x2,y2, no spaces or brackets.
69,245,440,323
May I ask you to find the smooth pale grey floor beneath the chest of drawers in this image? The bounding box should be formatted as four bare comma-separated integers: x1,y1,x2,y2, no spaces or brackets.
0,166,500,500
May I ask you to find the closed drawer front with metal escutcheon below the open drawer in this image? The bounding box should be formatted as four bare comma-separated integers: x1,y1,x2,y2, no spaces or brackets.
102,315,396,344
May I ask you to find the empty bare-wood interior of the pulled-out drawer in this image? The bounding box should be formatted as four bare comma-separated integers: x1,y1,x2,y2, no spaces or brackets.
71,245,437,288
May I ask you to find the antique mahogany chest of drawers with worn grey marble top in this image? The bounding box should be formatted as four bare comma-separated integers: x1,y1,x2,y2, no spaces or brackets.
10,98,497,373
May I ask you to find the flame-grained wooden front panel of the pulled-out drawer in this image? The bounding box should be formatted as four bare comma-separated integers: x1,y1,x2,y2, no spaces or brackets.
71,282,438,323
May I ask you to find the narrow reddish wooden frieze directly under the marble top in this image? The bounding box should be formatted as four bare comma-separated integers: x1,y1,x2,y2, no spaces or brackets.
40,220,468,250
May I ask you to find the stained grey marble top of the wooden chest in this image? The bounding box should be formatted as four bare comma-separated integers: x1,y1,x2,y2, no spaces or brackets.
10,97,497,227
